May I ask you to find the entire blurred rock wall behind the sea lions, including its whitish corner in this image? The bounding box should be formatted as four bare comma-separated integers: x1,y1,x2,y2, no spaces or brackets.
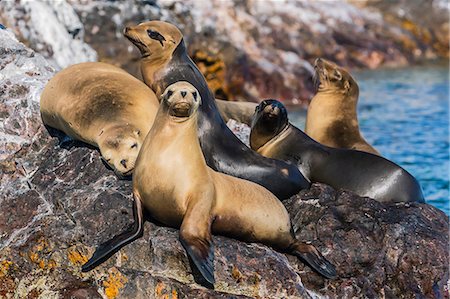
0,0,449,105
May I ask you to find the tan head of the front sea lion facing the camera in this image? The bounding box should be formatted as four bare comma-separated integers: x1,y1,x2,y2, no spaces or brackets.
161,81,201,122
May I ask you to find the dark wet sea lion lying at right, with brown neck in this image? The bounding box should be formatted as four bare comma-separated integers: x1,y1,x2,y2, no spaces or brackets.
250,100,424,202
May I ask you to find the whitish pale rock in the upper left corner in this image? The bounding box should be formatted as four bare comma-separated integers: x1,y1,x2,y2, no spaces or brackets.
0,0,97,68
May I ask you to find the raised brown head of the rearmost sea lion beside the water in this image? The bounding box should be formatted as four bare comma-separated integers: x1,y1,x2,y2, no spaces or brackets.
314,58,359,95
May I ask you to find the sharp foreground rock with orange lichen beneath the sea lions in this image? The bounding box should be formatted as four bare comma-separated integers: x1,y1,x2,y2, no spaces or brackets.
0,30,449,298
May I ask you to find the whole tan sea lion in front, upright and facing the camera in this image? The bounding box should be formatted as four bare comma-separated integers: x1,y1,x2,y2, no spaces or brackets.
83,81,336,284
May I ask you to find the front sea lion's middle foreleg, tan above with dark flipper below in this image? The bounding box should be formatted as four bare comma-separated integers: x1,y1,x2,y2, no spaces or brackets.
180,198,215,284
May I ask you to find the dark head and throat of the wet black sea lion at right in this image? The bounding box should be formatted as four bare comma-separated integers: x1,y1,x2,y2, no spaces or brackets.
250,99,289,150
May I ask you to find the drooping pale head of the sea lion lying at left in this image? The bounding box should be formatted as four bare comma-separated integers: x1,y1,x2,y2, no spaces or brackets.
99,125,142,177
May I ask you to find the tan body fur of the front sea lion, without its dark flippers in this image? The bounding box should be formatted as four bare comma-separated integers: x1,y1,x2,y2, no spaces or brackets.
133,82,294,248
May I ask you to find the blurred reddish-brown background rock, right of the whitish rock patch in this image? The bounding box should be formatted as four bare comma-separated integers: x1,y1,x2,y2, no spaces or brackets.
71,0,448,104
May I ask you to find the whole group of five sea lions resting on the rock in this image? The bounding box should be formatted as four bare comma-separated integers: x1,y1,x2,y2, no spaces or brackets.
41,21,423,284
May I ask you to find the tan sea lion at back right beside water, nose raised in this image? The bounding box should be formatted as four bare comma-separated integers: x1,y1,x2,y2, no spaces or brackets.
305,58,380,155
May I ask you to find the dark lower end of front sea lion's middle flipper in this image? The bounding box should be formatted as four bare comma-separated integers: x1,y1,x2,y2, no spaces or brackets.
180,235,215,284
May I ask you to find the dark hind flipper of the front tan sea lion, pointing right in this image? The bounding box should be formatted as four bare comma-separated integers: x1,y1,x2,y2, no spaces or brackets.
292,241,337,279
